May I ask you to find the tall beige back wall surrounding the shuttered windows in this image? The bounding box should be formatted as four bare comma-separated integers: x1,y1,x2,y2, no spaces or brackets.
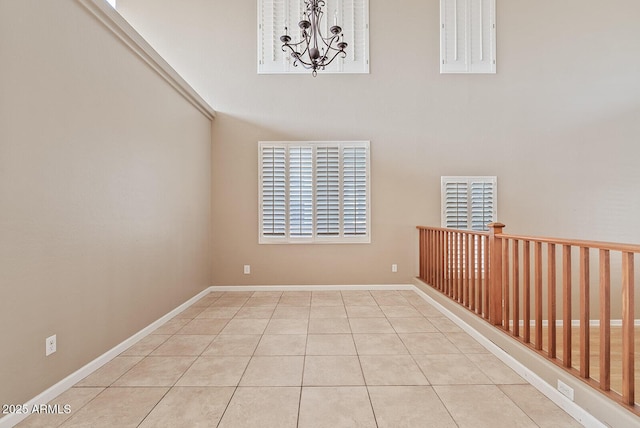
118,0,640,285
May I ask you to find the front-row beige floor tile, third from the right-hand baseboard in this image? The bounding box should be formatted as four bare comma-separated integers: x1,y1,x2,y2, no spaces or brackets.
369,386,457,428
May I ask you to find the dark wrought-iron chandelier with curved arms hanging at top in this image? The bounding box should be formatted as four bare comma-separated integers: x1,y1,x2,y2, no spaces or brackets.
280,0,347,77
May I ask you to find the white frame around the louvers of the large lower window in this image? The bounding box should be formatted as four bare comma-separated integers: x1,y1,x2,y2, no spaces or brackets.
258,141,371,244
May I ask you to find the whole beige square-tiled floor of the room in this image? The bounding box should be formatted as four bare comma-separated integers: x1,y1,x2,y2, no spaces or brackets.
18,291,580,428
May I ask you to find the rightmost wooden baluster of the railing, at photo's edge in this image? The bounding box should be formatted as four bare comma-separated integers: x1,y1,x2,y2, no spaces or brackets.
622,252,635,406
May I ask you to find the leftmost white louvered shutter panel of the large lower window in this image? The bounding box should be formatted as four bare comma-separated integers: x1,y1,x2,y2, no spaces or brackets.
260,147,287,236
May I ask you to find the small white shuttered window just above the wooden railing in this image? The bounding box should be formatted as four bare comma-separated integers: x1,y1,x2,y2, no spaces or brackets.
441,177,497,231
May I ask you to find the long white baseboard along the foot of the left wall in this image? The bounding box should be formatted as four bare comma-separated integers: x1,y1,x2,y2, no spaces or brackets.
0,288,210,428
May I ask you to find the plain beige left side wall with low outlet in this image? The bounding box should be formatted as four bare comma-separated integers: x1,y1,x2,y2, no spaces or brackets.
0,0,211,404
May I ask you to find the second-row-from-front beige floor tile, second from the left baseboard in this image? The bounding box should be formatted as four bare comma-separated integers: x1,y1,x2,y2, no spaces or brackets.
114,357,196,386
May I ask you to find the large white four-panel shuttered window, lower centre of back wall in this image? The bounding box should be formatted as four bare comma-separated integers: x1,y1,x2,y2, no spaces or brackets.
259,141,371,243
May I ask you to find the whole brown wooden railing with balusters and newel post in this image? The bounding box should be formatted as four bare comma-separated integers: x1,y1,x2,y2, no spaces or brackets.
418,223,640,414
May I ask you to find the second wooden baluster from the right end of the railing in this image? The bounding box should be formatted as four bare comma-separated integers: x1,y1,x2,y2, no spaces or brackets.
600,250,611,391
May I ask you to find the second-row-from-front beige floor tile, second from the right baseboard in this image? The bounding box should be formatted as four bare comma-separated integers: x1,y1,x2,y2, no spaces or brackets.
414,354,493,385
